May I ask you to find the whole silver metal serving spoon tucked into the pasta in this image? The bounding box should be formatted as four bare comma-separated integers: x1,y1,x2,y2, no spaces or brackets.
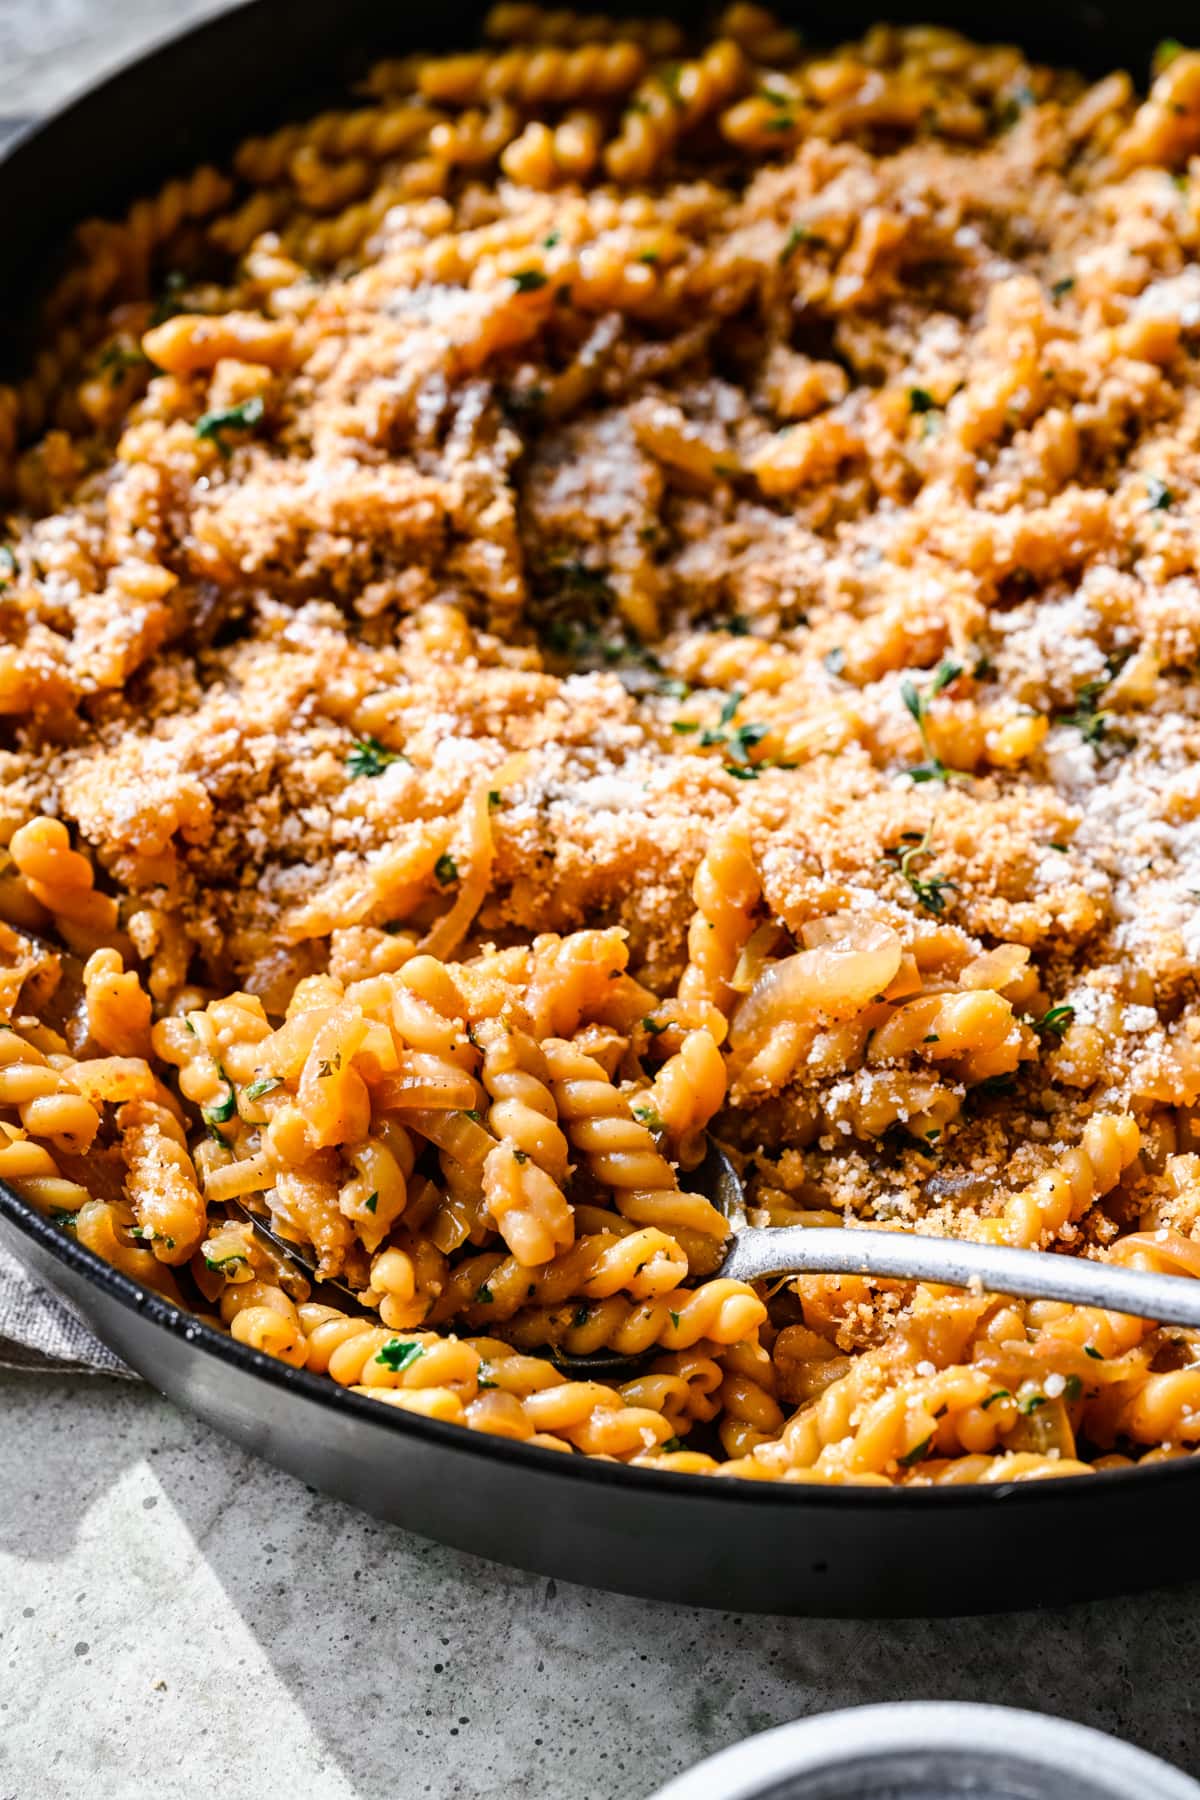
234,1138,1200,1375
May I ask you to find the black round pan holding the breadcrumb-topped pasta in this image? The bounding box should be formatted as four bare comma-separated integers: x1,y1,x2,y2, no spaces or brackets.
0,0,1200,1616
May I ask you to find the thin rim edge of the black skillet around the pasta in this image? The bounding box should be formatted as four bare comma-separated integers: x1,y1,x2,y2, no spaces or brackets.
0,0,1200,1519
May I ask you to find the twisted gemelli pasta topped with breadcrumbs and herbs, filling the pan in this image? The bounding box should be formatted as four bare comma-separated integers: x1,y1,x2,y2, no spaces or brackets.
0,4,1200,1485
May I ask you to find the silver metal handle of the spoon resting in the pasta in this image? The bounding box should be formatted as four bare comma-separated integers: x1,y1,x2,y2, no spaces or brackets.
721,1226,1200,1327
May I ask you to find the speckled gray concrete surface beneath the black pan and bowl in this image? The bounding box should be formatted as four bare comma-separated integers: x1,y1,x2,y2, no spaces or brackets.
0,10,1200,1800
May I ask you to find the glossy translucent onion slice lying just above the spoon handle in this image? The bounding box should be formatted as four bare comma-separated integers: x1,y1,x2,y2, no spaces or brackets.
729,913,903,1048
